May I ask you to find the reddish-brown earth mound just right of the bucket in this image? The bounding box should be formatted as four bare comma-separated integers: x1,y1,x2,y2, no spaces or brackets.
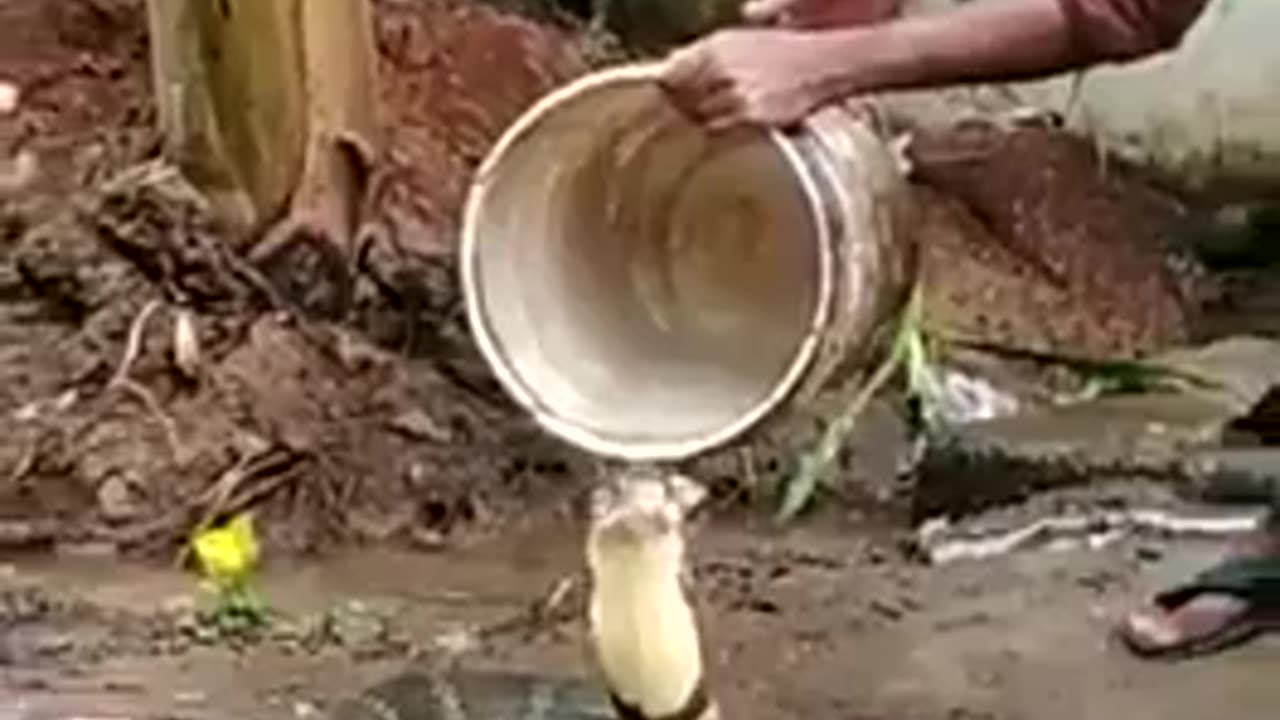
911,122,1210,360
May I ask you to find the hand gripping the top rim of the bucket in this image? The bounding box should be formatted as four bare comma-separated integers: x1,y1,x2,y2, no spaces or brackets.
659,28,841,131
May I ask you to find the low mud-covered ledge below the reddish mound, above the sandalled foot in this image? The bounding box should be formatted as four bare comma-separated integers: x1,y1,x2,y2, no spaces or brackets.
913,337,1280,520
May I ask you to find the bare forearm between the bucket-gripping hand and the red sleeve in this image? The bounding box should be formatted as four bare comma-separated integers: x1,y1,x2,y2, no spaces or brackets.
824,0,1093,94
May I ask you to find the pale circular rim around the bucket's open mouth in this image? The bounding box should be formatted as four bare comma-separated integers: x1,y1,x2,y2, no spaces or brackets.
458,61,836,453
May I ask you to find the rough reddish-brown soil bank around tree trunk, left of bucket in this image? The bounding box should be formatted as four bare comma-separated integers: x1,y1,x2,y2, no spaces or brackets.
0,0,619,552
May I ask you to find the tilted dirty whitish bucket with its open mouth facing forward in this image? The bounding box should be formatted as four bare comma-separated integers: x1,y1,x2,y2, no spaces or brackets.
461,64,914,461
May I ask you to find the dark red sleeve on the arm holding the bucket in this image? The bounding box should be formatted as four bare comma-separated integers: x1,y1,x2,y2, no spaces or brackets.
1059,0,1207,61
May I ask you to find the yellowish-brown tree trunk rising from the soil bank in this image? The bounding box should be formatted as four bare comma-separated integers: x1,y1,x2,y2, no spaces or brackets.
147,0,379,314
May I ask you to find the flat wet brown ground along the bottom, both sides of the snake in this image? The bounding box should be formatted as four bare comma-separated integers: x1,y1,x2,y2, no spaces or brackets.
0,509,1280,720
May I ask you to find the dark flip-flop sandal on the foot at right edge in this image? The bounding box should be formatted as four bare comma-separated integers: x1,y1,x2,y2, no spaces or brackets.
1116,556,1280,660
